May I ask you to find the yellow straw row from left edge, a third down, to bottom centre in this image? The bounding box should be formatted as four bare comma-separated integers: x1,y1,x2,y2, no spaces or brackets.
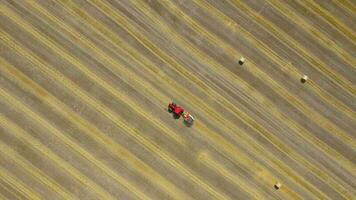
0,58,191,200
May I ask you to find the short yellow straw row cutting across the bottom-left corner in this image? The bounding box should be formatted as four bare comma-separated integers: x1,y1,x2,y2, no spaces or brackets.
0,163,41,200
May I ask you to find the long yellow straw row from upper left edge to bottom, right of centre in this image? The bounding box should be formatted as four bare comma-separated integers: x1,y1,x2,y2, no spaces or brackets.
0,31,230,200
